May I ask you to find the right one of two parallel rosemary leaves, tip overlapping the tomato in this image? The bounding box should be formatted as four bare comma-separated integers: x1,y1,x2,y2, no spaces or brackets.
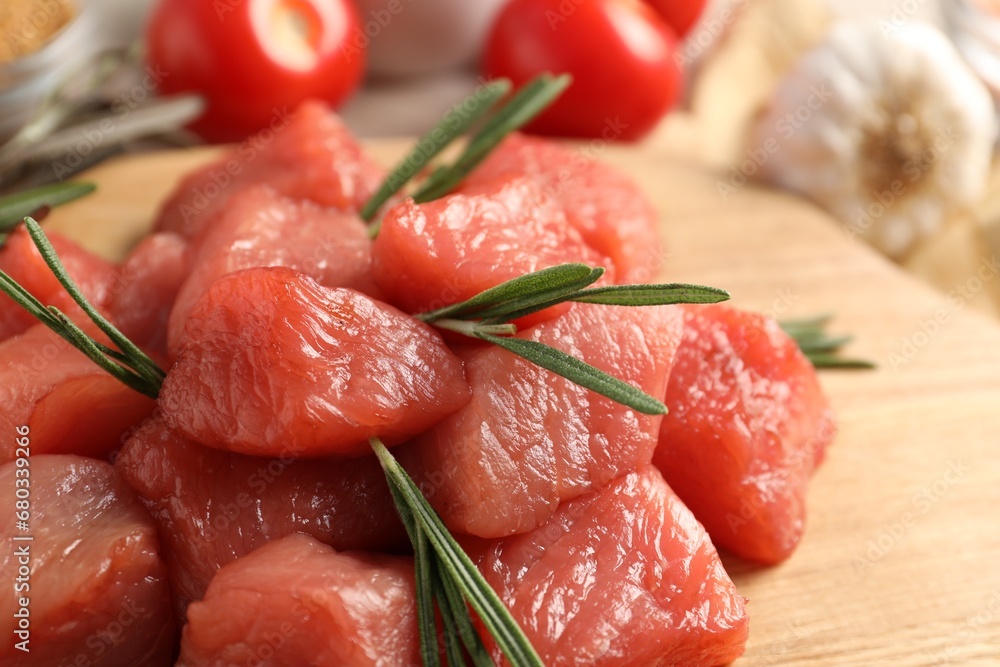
413,74,573,203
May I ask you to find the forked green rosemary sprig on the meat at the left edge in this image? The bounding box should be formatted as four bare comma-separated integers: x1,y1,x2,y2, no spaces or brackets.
0,218,166,398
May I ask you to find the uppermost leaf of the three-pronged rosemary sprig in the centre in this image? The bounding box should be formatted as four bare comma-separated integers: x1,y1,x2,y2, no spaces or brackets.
416,264,604,322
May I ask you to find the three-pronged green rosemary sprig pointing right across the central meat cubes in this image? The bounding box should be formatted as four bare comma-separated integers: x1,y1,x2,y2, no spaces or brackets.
415,264,729,415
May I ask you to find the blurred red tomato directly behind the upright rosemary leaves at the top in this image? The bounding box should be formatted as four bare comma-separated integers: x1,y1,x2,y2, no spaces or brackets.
483,0,683,141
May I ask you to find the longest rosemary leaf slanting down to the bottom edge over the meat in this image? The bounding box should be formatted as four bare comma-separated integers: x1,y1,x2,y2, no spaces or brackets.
369,438,544,667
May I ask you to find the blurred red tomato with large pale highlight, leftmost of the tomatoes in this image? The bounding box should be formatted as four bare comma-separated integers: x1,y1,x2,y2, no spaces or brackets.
146,0,365,141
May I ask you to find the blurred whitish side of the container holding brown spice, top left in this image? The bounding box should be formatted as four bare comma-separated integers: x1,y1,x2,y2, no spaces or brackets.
0,0,97,142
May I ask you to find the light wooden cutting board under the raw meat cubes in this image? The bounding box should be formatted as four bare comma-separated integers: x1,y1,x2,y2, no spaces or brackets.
41,142,1000,667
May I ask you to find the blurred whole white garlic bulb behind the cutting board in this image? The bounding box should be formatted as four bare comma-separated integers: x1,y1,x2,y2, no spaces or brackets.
747,23,997,259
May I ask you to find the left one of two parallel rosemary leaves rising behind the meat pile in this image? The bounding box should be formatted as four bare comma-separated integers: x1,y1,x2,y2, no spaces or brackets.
361,79,511,222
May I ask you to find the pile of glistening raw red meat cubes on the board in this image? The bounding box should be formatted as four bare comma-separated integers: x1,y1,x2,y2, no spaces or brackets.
0,104,834,667
